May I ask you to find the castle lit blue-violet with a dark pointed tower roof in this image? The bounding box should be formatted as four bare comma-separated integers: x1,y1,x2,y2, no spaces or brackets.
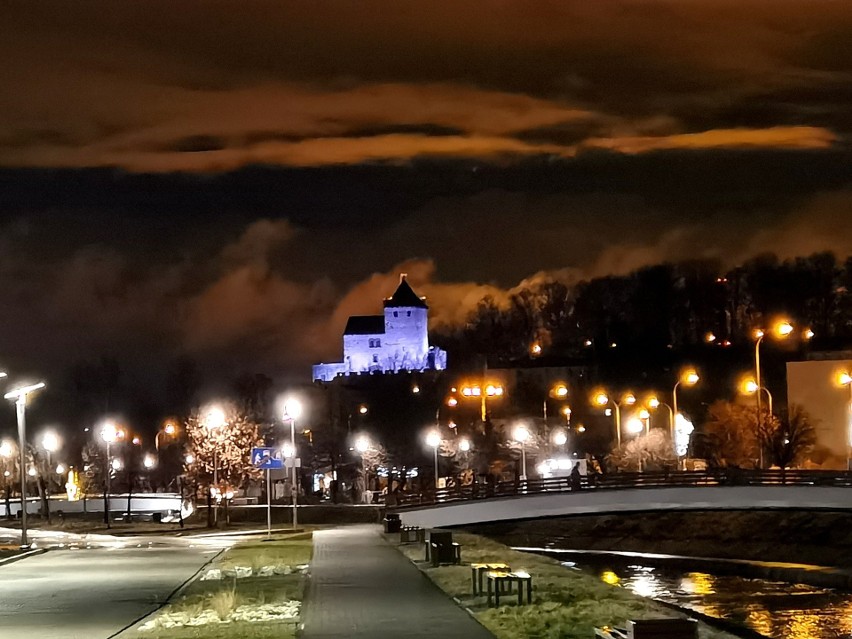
313,273,447,382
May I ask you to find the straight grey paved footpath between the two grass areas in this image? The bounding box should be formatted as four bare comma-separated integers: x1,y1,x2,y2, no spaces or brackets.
302,526,494,639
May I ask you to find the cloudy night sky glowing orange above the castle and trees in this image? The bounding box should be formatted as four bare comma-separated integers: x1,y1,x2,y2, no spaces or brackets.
0,0,852,400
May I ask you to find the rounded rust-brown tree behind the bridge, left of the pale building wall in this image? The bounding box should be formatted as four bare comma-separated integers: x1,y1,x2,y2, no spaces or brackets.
702,400,779,468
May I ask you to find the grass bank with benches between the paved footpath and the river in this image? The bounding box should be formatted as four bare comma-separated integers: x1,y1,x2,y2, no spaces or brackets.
398,533,734,639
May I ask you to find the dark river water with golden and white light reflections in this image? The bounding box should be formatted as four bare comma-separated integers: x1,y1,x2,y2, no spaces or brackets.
588,561,852,639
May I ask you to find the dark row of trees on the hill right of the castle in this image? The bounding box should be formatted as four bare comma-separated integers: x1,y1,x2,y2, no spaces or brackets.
438,253,852,364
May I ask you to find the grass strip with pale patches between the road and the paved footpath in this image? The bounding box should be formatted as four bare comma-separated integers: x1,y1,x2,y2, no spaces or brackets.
116,532,313,639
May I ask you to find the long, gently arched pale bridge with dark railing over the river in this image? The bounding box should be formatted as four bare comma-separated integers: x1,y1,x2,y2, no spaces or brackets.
396,471,852,528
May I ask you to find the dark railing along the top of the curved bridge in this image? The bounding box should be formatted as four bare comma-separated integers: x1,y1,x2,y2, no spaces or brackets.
396,468,852,507
